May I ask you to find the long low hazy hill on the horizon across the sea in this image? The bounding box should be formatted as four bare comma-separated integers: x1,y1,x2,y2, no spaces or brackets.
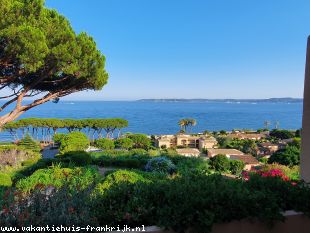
137,98,303,103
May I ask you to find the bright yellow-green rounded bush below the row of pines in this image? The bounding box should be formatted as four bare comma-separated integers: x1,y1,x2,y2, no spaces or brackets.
59,132,89,154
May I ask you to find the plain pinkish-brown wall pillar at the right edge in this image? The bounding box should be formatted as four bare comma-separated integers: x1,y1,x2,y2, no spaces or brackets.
300,36,310,182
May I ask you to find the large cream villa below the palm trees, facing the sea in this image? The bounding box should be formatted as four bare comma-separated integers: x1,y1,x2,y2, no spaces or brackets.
155,134,217,150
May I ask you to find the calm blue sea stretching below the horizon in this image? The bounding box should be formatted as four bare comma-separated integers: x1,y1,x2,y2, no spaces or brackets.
0,101,302,140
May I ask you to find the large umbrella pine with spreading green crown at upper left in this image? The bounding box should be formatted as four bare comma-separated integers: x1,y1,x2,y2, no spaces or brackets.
0,0,108,127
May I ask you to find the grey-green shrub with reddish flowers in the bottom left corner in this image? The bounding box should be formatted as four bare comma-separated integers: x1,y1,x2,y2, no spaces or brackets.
0,187,99,227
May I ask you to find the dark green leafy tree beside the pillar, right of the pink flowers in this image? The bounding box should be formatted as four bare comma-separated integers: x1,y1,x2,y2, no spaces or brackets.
268,145,300,166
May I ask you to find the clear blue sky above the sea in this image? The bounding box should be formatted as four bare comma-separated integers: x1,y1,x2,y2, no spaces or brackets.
46,0,310,100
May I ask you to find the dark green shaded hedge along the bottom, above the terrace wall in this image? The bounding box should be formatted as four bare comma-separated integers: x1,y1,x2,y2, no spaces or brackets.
95,175,310,232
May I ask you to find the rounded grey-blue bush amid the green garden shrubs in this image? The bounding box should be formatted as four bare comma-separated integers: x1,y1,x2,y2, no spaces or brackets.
145,157,176,174
